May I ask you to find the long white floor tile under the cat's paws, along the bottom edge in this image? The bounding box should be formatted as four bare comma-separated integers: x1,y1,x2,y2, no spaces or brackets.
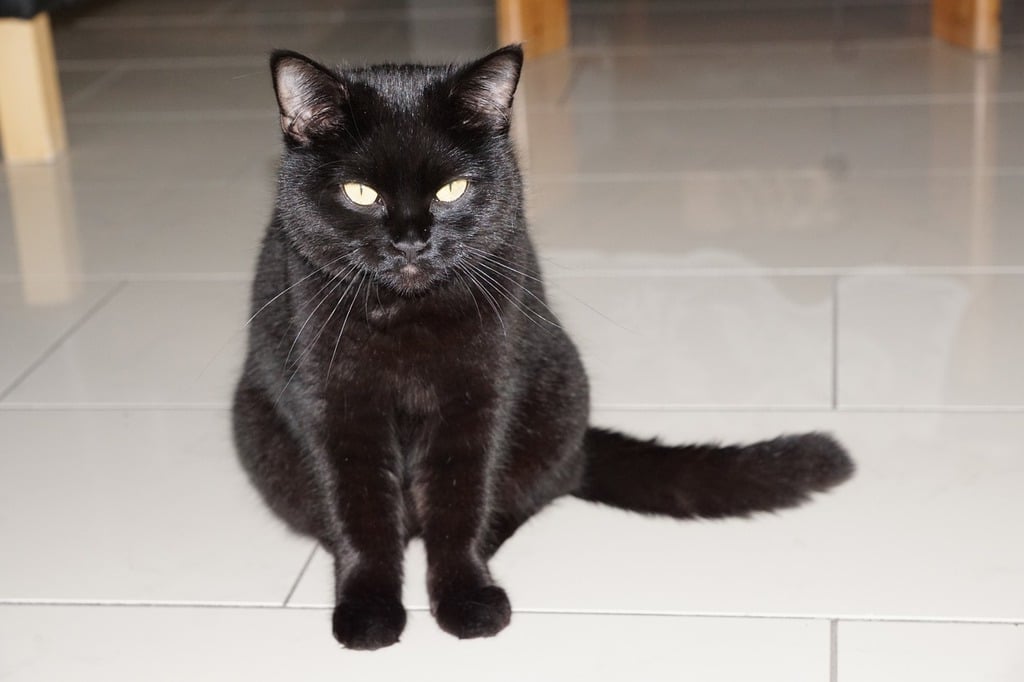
0,606,828,682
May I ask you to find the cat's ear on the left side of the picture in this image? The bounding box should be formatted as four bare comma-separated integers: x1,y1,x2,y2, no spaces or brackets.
270,50,345,144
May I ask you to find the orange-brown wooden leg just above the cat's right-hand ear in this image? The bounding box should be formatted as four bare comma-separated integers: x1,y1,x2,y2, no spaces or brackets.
497,0,569,57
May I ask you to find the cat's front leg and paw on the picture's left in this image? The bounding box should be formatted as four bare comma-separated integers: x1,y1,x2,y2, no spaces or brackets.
325,414,406,649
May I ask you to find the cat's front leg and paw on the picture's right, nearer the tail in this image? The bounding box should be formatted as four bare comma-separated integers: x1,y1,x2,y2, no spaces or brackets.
413,393,512,638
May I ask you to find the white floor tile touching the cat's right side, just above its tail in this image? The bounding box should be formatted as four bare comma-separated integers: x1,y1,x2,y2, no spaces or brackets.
538,268,831,407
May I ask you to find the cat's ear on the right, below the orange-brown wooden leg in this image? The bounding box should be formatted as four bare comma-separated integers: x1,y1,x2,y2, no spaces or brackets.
452,45,522,133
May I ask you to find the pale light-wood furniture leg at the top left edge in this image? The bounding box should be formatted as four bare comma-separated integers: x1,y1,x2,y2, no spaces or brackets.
0,13,68,163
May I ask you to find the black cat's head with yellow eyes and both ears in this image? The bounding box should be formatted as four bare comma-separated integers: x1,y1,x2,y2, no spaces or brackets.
270,46,522,295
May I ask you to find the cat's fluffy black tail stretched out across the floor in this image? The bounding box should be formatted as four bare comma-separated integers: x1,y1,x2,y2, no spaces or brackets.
572,428,854,518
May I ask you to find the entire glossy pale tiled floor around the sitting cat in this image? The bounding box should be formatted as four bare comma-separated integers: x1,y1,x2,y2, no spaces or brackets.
0,0,1024,682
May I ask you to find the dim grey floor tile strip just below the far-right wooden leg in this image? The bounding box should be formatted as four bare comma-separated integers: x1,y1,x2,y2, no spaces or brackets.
569,42,1024,106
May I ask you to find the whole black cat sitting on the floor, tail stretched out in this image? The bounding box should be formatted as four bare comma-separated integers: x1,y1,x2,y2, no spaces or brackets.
233,46,853,649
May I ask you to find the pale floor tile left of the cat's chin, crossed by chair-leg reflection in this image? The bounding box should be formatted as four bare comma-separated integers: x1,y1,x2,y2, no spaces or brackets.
0,179,273,279
